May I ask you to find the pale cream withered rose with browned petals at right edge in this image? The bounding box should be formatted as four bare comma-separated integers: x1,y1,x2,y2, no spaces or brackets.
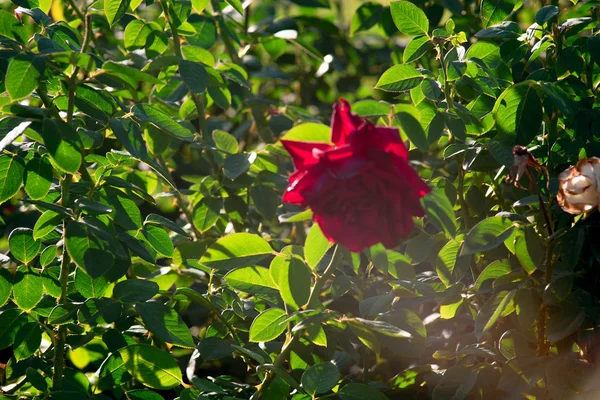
556,157,600,214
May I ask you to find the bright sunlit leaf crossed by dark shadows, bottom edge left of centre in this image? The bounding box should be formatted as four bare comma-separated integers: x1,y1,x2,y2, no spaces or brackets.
119,344,182,390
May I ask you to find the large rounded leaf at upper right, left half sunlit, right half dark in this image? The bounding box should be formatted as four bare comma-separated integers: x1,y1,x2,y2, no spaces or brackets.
492,81,542,146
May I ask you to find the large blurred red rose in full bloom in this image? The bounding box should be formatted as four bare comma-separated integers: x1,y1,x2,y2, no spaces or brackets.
281,99,430,252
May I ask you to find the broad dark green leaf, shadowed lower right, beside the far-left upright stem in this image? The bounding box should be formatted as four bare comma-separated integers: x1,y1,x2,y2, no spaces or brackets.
65,221,115,278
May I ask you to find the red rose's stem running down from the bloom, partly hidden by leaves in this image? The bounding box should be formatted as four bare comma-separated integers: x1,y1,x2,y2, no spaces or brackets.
255,244,342,400
